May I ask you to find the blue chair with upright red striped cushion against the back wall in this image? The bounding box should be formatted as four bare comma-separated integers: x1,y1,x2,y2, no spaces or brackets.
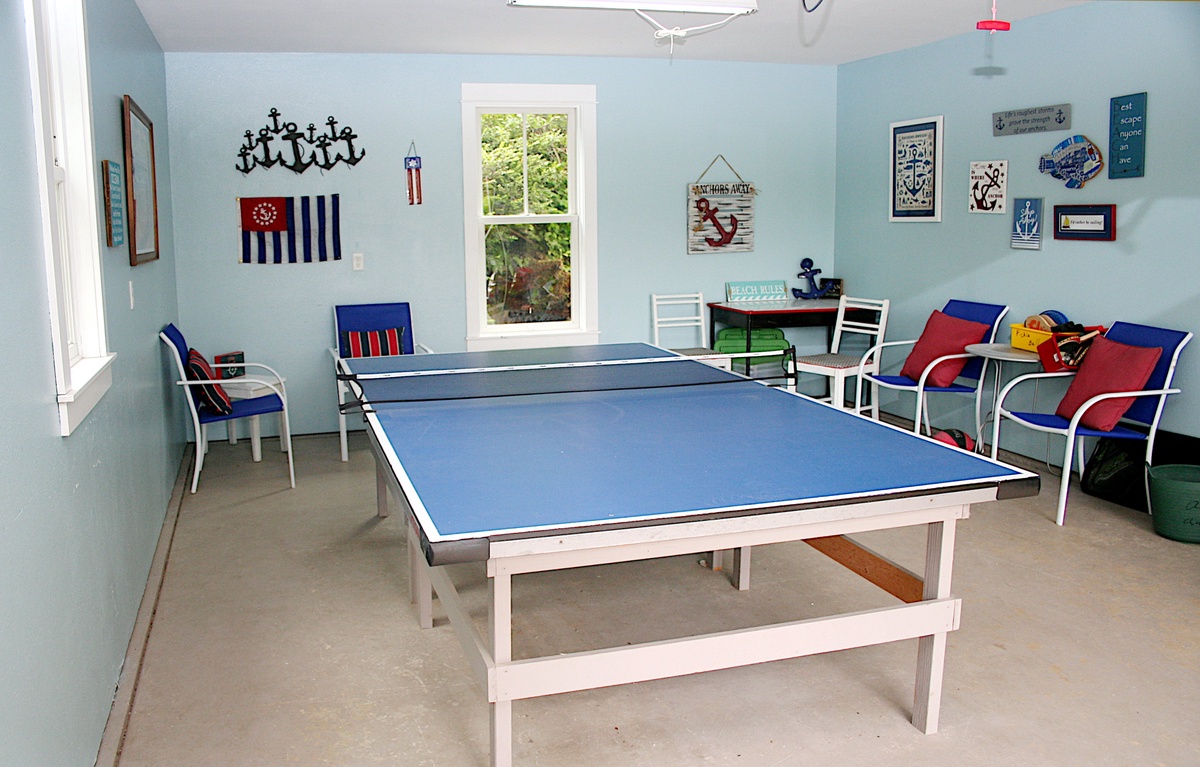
329,301,431,461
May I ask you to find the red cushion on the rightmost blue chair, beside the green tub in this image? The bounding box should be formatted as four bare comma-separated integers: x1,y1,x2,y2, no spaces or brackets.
1055,336,1163,431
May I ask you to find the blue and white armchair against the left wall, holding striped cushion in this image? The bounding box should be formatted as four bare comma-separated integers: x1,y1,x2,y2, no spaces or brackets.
158,324,296,492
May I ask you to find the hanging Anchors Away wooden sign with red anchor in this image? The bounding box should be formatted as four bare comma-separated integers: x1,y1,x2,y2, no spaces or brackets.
688,155,756,253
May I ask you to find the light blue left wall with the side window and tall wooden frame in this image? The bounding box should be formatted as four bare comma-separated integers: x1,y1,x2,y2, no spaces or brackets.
0,0,182,767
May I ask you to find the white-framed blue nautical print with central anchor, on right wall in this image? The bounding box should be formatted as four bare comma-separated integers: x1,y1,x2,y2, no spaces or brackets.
888,115,942,222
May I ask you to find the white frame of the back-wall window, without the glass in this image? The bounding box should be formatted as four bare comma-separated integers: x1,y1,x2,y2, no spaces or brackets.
462,83,600,352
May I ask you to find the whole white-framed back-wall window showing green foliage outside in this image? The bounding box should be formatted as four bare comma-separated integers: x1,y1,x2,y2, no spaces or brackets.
462,84,599,350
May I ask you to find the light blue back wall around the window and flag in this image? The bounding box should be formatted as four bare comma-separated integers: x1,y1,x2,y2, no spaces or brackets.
167,54,836,433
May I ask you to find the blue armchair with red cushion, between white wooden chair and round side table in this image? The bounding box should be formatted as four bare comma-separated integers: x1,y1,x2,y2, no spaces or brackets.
856,299,1008,439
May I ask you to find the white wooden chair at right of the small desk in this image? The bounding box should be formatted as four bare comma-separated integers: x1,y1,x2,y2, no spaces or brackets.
794,295,890,413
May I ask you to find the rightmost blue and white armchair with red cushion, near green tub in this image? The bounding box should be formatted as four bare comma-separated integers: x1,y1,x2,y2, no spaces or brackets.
991,322,1192,525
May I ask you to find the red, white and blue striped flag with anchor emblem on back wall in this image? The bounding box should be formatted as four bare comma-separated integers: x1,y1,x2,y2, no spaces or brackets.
238,194,342,264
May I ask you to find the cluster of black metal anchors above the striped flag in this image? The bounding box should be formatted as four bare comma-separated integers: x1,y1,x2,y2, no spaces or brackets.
234,107,367,174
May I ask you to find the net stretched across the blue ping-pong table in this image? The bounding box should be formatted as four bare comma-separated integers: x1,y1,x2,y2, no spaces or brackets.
338,348,796,413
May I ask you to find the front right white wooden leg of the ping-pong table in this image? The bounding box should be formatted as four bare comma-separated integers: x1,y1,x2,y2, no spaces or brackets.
912,520,954,735
